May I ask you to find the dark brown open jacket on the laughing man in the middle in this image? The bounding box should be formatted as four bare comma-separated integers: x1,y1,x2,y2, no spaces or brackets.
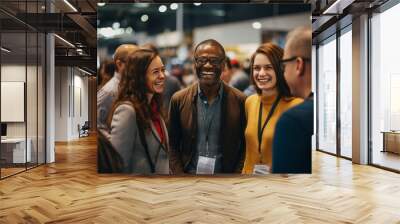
168,82,246,174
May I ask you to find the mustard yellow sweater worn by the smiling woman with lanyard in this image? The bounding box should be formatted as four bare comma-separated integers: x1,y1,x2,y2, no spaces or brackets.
242,94,303,174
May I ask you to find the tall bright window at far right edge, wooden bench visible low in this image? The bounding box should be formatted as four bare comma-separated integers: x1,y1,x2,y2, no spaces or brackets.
370,4,400,171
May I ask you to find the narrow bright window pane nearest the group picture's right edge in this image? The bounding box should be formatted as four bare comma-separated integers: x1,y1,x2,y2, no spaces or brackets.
318,38,336,153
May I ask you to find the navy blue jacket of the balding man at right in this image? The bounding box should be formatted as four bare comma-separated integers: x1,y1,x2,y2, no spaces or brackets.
272,99,314,173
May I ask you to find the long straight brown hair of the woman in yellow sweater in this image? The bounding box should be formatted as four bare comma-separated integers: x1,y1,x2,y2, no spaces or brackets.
250,43,291,97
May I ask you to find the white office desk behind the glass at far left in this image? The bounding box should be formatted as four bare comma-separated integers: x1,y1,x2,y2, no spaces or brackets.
1,138,32,163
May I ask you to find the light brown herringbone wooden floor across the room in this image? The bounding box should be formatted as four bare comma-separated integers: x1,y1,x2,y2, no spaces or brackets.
0,137,400,224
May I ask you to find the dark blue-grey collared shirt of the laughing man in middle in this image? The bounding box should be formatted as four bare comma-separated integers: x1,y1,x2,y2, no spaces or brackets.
189,84,223,173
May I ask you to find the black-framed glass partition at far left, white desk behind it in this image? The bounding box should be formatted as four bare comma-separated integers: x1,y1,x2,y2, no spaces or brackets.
0,1,46,179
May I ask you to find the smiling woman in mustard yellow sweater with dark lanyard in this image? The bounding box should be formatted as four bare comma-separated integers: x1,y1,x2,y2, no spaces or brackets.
242,43,302,174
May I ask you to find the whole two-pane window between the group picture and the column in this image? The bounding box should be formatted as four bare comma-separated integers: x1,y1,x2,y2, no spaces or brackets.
315,25,352,159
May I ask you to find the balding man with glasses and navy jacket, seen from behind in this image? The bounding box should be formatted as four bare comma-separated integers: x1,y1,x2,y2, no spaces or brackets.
272,27,314,173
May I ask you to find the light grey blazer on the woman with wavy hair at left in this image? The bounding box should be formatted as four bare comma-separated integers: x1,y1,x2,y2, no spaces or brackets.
101,101,169,174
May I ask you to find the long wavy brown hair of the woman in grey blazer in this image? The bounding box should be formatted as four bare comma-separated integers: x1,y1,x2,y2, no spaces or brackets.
109,49,161,128
